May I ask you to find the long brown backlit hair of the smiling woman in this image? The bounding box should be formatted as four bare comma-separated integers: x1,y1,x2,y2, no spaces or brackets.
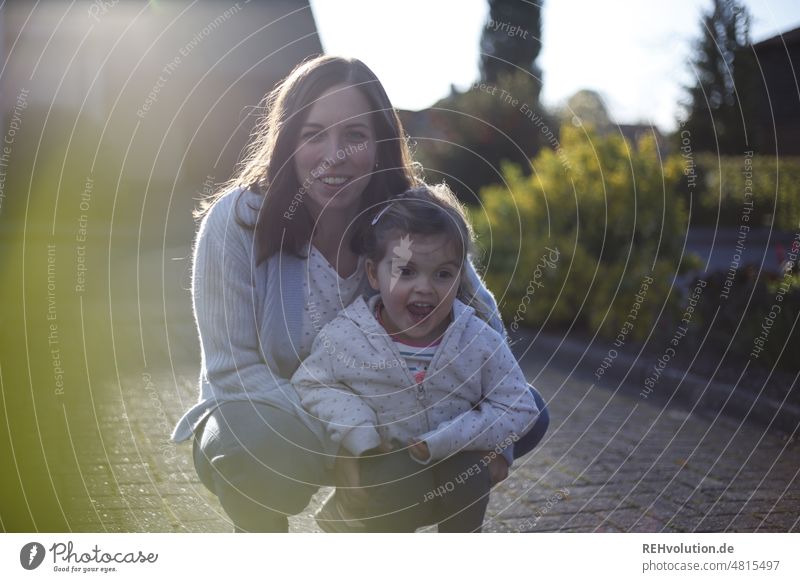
200,56,418,262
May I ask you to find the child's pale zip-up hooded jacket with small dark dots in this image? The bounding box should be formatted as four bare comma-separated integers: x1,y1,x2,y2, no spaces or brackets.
292,295,539,462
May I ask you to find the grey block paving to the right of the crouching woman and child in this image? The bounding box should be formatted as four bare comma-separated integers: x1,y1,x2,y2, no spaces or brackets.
487,358,800,532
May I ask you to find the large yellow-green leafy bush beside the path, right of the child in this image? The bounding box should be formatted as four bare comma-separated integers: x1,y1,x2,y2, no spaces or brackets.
472,126,691,341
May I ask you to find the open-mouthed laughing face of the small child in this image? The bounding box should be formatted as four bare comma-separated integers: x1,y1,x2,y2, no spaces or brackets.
365,233,462,345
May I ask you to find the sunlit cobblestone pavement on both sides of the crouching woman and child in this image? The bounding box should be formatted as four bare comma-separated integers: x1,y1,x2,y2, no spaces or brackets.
54,318,800,532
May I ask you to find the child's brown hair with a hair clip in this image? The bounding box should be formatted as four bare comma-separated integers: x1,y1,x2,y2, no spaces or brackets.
354,184,475,264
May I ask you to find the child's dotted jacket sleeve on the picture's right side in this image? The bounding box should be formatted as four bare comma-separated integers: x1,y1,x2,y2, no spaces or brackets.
418,327,539,460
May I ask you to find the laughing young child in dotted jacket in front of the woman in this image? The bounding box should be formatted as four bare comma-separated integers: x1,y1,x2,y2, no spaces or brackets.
292,186,538,531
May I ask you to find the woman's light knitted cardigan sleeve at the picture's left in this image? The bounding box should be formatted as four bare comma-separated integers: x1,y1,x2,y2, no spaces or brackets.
192,191,286,396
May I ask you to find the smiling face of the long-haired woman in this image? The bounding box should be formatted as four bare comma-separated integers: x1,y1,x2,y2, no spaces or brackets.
294,85,376,218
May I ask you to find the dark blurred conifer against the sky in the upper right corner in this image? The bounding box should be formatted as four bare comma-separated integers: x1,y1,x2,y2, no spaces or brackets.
681,0,757,154
